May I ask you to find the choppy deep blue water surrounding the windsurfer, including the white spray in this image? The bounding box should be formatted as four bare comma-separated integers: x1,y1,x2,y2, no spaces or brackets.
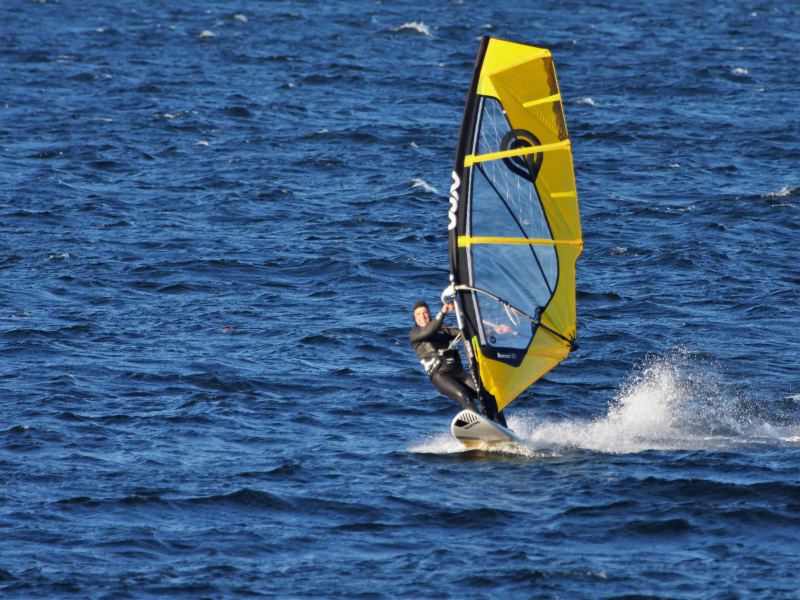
0,0,800,599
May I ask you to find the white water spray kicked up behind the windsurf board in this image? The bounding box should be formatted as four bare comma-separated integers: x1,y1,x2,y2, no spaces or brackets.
509,353,800,453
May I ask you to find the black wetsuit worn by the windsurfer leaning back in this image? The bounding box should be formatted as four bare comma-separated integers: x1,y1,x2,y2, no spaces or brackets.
408,312,477,412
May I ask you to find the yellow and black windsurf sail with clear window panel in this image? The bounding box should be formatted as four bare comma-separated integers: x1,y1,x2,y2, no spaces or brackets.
446,37,583,410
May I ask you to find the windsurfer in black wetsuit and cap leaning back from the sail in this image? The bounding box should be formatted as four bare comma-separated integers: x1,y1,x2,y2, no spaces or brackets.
408,300,506,427
